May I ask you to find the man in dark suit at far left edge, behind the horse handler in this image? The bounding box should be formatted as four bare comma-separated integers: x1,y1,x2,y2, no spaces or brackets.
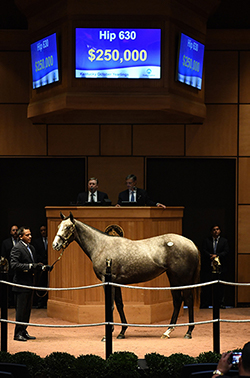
1,225,19,307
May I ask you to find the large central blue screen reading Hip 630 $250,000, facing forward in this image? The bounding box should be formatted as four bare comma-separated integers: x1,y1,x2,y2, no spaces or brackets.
75,28,161,79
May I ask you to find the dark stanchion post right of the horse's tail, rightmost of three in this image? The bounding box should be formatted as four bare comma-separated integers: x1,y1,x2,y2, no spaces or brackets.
212,259,220,353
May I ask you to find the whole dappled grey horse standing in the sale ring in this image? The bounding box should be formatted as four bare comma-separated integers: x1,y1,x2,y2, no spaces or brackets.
52,213,200,339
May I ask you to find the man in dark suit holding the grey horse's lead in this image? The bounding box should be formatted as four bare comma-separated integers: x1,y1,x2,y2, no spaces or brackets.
10,227,51,341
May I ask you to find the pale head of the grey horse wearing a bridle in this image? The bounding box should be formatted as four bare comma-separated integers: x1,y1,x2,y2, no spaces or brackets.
52,212,75,251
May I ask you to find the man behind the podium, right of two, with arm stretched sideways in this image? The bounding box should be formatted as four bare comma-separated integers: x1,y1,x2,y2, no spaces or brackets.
116,174,166,209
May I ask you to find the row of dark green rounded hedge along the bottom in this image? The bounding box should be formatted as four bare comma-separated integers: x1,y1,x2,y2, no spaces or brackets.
0,349,240,378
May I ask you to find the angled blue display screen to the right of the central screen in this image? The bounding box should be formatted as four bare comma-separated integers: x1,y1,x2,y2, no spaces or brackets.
176,33,205,89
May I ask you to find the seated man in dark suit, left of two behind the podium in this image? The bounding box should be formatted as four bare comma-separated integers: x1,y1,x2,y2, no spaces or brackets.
77,177,108,206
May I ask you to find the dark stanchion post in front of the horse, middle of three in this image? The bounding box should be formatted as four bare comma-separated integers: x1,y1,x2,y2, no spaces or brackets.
105,259,113,359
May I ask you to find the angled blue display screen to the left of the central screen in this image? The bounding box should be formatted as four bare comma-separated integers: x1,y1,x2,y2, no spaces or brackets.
30,33,59,89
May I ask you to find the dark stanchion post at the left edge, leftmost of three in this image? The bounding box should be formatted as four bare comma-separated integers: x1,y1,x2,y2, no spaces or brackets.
0,257,9,352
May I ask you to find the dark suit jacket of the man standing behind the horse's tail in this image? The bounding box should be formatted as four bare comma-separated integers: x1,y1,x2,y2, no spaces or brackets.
201,236,229,273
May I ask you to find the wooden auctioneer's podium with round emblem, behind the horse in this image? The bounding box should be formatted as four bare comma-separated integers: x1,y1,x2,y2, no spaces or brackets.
46,206,184,324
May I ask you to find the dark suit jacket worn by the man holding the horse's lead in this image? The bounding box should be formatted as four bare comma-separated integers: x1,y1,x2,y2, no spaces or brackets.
10,240,37,292
